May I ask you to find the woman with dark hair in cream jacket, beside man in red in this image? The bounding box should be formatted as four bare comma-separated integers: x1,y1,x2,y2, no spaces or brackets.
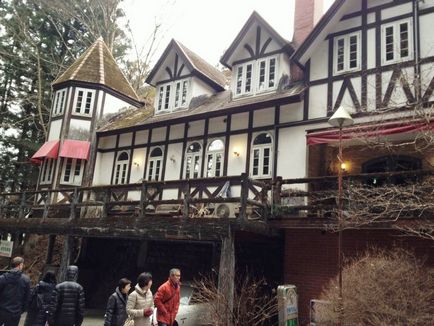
127,273,154,326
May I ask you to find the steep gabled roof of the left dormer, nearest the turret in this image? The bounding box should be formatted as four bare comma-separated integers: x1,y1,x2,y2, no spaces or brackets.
146,39,227,91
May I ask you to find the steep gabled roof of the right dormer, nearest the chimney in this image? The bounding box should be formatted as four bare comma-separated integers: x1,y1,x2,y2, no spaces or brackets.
220,11,294,69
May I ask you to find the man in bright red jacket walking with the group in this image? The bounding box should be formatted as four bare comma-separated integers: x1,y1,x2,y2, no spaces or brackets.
154,268,181,326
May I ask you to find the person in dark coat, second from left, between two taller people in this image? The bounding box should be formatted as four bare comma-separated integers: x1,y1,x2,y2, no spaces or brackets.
24,271,56,326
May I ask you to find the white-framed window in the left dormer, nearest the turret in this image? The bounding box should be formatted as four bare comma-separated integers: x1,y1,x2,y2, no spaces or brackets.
155,79,189,113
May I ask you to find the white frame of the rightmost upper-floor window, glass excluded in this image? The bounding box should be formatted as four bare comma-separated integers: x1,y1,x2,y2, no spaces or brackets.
381,19,414,64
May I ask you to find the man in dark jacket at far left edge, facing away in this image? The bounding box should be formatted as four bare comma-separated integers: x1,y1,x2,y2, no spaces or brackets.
0,257,30,326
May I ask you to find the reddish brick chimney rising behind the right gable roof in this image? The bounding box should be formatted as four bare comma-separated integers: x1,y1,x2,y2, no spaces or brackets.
292,0,324,47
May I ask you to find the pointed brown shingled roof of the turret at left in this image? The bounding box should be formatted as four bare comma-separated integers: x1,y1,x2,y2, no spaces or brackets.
53,38,139,101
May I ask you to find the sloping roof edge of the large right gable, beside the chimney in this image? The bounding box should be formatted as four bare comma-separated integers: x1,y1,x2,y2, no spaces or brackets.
292,0,351,66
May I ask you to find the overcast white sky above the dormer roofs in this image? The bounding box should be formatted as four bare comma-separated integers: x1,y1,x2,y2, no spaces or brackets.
120,0,333,65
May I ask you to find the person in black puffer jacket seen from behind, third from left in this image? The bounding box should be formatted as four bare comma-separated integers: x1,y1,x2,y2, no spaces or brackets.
49,265,84,326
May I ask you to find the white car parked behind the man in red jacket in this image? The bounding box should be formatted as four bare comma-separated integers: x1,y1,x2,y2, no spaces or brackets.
153,284,212,326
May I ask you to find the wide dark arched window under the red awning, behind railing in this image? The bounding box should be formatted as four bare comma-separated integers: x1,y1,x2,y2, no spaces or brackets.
362,155,422,186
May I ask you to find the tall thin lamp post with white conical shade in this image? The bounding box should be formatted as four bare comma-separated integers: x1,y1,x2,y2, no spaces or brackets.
328,106,354,325
